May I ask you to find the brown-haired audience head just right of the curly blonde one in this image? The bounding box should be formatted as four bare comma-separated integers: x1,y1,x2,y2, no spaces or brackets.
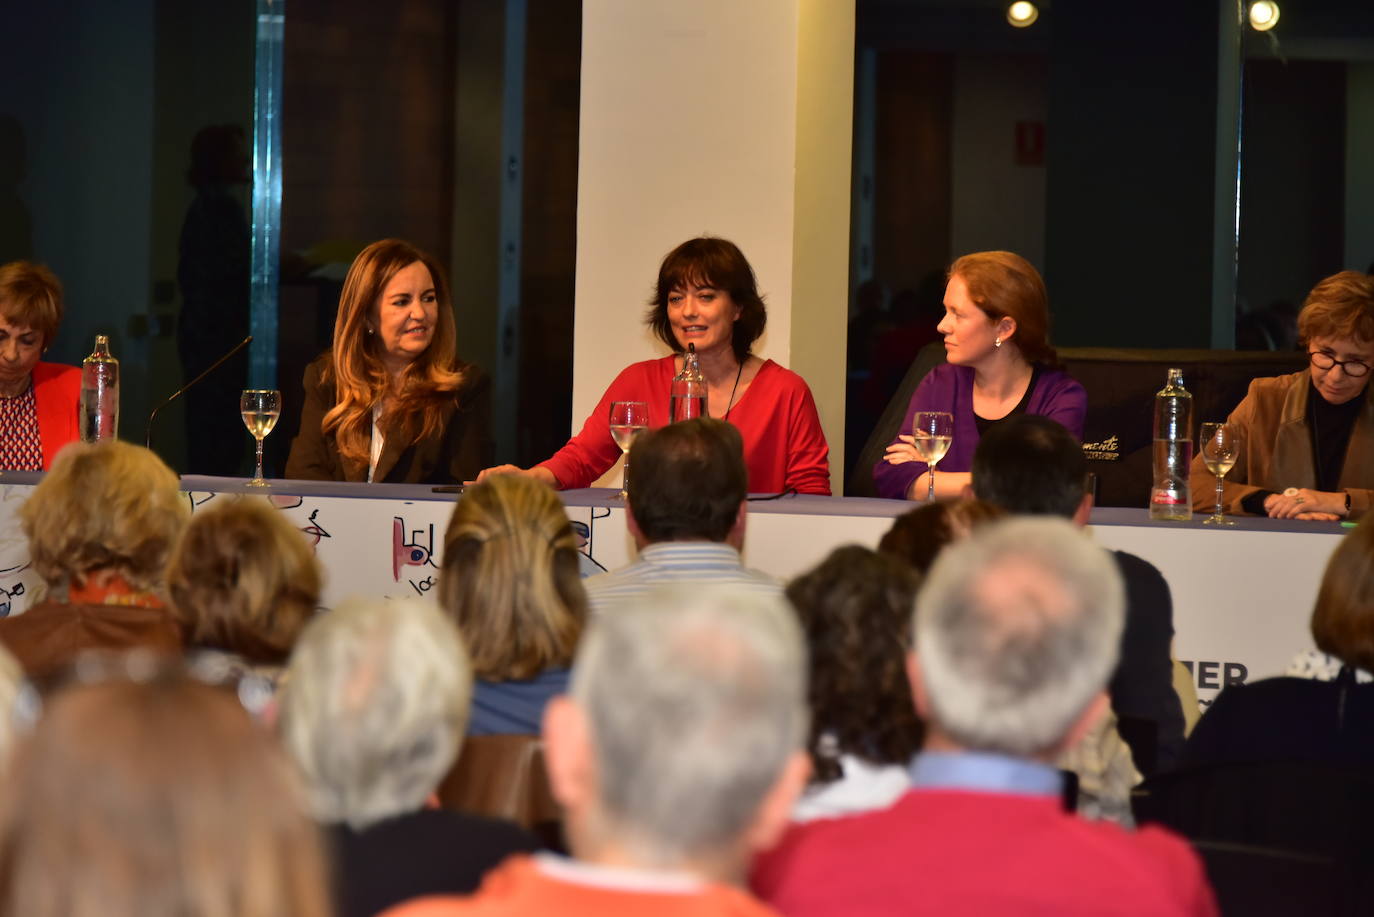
168,498,320,665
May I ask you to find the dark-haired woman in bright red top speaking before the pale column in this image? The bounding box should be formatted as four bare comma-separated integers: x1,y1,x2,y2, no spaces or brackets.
478,238,830,495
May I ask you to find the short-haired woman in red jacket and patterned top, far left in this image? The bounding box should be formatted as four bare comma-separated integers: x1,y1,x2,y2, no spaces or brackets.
0,261,81,472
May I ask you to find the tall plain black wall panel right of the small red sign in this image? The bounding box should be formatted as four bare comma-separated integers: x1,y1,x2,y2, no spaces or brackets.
1044,0,1217,348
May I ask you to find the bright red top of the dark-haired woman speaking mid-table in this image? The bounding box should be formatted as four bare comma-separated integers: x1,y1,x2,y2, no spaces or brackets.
540,356,830,496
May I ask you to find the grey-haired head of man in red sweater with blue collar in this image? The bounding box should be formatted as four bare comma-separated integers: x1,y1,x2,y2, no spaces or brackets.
914,518,1125,758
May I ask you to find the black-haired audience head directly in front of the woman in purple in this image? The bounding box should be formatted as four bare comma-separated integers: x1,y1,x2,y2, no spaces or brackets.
970,414,1092,524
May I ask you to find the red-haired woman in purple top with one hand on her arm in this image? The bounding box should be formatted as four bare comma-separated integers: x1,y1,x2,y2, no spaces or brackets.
872,252,1088,500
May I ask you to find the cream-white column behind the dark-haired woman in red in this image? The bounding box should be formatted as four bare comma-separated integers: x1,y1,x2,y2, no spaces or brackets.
573,0,855,492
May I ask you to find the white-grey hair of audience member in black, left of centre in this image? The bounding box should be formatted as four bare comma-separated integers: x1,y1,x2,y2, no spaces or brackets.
280,598,473,829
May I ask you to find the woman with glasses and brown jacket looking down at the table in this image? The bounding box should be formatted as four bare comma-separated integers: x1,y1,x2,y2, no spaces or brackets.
1193,271,1374,521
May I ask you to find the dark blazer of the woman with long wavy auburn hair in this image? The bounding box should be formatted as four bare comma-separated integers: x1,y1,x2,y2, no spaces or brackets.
286,353,493,484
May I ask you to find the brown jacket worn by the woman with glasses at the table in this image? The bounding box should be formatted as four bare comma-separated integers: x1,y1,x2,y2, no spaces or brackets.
1193,370,1374,518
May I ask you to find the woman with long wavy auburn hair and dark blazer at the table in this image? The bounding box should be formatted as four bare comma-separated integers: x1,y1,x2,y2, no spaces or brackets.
286,239,491,484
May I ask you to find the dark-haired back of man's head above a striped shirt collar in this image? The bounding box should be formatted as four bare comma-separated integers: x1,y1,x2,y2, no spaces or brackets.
629,417,749,547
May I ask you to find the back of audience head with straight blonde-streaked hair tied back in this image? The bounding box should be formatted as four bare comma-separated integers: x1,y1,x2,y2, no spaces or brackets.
438,474,587,681
